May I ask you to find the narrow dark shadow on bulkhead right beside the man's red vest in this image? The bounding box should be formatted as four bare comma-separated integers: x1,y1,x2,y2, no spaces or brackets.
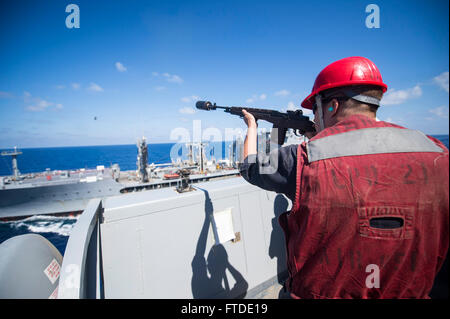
269,194,289,284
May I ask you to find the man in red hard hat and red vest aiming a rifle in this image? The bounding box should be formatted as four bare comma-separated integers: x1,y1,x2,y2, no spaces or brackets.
240,57,449,298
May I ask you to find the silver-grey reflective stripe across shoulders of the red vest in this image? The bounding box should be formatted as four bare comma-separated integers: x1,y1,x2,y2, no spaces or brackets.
306,127,443,163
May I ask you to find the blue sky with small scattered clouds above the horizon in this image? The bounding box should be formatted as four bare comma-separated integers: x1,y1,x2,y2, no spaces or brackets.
0,0,449,148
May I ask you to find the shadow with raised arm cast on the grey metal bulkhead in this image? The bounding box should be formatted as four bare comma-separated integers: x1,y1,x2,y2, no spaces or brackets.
191,188,248,298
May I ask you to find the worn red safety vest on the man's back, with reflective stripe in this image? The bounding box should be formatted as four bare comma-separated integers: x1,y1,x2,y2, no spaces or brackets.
279,115,449,298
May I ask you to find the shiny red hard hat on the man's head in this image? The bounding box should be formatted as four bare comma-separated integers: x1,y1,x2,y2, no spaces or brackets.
301,56,387,109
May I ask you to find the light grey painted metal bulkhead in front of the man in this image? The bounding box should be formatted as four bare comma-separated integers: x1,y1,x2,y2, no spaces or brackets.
59,177,291,298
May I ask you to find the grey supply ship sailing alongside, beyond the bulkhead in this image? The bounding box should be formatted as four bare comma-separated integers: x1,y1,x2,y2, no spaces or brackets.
0,138,250,219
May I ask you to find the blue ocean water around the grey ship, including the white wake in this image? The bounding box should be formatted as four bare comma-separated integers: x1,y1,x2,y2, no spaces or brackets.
0,135,449,255
